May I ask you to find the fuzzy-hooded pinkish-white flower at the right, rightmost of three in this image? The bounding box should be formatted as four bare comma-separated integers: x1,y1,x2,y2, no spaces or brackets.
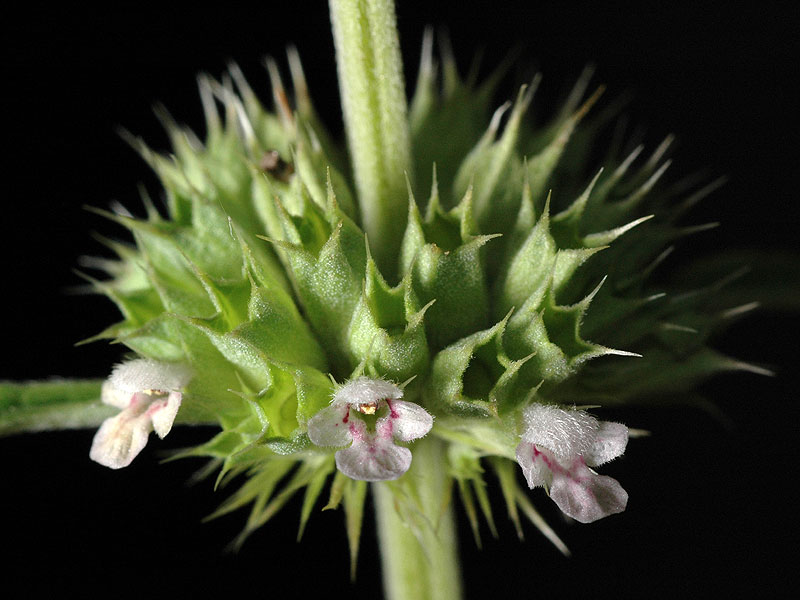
517,404,628,523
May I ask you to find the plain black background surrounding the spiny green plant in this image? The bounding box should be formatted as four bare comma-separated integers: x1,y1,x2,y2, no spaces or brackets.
0,1,800,598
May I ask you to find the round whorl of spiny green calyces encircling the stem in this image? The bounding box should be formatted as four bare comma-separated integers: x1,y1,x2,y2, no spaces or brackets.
78,39,760,552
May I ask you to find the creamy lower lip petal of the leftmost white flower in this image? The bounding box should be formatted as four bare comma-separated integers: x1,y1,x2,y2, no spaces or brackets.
89,410,151,469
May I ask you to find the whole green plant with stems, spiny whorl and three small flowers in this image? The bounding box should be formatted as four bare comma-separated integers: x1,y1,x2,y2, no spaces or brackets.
0,0,776,599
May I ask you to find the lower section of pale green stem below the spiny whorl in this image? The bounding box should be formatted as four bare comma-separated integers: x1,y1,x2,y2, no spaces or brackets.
373,436,461,600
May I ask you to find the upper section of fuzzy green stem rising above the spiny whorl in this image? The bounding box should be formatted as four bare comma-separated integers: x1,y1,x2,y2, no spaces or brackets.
330,0,412,277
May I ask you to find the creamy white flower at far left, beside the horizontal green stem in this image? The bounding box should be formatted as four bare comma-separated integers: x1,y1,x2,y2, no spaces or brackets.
89,358,191,469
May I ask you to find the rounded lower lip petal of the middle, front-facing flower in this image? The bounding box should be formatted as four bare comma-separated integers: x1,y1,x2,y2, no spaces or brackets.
336,435,411,481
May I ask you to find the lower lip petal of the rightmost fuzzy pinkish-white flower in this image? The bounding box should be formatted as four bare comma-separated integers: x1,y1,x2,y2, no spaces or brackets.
550,457,628,523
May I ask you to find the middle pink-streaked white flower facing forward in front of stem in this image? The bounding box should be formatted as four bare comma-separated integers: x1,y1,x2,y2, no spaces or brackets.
308,377,433,481
